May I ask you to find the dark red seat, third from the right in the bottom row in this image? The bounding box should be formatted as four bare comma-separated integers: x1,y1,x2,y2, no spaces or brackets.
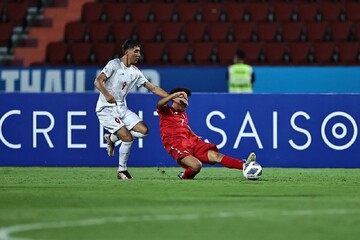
289,42,312,65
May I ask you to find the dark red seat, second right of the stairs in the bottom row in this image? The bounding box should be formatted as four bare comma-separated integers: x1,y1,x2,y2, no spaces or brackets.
69,42,92,66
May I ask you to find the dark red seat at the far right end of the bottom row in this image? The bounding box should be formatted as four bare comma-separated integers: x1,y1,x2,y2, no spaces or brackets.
338,42,360,65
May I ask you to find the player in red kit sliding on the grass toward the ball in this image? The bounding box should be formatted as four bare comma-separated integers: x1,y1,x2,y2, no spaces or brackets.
157,88,256,179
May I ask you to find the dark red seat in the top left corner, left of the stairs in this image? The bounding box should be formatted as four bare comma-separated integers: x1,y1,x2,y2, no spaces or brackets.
3,1,28,26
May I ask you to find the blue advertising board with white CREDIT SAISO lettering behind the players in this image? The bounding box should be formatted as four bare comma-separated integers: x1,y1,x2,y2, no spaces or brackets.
0,93,360,168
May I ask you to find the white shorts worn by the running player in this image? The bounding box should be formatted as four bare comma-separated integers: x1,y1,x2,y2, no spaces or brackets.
96,107,142,133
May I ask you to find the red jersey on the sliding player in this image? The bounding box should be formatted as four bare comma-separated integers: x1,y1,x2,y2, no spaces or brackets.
157,105,193,140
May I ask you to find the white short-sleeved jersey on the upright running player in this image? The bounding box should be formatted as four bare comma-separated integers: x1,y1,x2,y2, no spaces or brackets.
96,58,148,112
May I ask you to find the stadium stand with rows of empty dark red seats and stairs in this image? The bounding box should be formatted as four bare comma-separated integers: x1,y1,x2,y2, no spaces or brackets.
0,0,360,66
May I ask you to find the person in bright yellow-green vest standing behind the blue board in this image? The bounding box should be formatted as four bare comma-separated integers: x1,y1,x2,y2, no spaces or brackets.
227,50,255,93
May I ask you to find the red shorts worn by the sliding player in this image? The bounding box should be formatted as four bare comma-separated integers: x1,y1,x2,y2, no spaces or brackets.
163,136,219,165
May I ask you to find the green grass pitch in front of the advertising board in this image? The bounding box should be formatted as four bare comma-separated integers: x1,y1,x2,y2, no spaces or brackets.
0,167,360,240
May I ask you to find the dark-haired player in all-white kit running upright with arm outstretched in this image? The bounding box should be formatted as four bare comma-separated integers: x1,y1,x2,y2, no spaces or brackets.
94,40,169,179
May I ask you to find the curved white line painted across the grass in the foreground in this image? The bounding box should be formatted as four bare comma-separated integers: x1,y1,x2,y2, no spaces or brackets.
0,209,360,240
